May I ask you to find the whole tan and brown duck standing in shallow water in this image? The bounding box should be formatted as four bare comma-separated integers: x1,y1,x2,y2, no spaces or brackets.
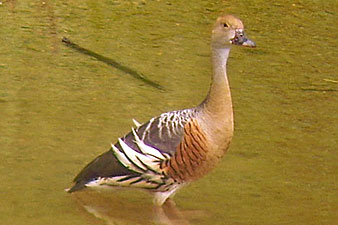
67,15,256,206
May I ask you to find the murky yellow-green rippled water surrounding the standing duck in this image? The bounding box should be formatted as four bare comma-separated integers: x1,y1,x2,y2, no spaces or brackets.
0,0,338,225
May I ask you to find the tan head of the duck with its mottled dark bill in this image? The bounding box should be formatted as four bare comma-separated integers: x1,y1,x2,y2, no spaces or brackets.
211,15,256,48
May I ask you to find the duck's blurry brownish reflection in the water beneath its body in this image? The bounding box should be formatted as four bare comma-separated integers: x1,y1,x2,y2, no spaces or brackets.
72,191,196,225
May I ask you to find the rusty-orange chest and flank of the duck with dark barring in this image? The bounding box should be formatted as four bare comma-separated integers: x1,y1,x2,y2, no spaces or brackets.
162,120,232,182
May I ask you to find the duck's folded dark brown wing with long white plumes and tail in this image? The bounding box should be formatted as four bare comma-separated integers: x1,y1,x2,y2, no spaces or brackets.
68,109,196,192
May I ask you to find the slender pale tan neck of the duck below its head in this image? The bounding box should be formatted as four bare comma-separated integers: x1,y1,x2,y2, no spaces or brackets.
200,47,233,139
